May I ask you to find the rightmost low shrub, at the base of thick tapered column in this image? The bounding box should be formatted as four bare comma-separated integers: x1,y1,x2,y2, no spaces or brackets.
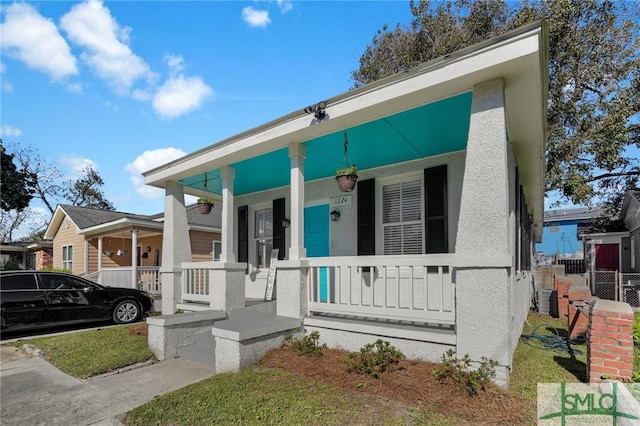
433,349,498,396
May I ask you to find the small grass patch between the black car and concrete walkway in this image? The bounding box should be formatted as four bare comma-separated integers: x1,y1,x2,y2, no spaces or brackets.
6,324,153,379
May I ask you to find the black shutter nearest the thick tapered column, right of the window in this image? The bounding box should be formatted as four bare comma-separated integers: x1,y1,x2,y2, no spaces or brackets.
424,165,449,254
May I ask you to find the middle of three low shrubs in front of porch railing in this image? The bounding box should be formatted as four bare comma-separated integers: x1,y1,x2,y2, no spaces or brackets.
343,339,404,378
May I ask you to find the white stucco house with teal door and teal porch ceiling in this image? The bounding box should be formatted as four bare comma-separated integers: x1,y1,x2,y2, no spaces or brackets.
144,22,548,384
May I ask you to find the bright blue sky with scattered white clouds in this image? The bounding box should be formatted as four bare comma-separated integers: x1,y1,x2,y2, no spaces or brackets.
0,0,411,238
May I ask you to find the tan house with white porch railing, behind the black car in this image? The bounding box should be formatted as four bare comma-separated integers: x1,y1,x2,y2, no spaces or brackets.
45,203,222,293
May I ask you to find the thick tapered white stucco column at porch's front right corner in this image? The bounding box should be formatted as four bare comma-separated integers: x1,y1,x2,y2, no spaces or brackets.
455,79,512,384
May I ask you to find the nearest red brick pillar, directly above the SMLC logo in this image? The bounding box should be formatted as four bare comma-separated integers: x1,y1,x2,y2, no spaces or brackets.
587,299,633,383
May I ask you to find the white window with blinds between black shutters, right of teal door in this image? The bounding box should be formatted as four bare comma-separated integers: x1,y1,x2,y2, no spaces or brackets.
382,179,424,255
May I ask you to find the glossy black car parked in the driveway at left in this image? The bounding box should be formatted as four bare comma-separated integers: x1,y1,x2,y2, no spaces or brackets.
0,271,153,331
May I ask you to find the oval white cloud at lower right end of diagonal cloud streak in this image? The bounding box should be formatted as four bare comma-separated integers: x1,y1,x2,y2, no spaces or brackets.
153,75,214,118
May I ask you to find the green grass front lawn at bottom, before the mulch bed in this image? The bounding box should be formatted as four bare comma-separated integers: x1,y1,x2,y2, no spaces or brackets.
124,366,428,426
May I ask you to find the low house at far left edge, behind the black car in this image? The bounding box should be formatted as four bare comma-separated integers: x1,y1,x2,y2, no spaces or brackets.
0,241,53,269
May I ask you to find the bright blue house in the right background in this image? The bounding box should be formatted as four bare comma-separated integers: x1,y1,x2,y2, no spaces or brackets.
536,207,601,259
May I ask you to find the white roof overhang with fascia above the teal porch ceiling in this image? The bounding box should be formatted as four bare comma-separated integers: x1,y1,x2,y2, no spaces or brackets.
143,21,548,239
